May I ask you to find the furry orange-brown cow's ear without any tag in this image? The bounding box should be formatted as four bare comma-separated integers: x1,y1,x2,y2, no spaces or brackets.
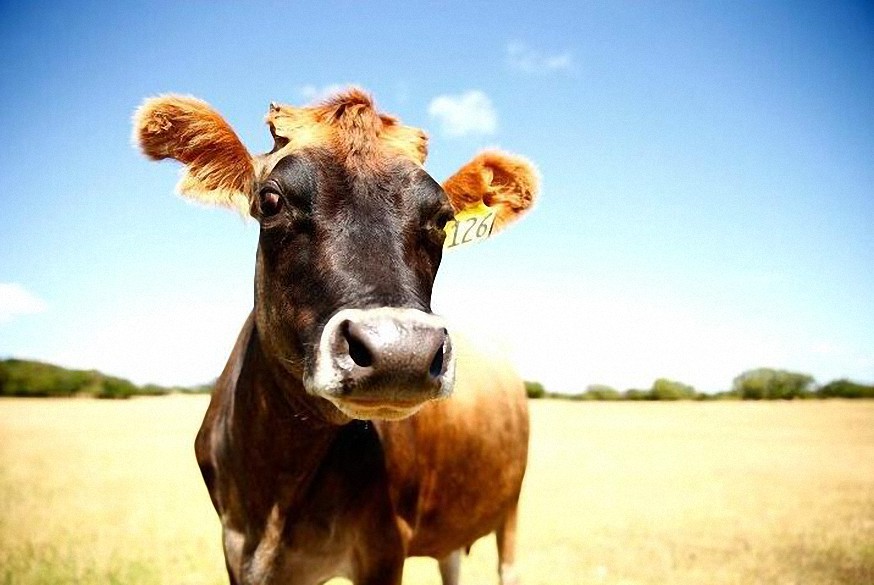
134,95,254,213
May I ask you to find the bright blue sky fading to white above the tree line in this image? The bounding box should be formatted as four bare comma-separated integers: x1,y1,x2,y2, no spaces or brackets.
0,1,874,392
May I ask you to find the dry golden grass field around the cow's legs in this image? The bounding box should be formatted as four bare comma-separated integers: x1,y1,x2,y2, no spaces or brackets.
0,396,874,585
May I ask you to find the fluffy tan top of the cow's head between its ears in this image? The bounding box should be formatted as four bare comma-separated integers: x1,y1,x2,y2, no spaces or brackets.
258,89,428,177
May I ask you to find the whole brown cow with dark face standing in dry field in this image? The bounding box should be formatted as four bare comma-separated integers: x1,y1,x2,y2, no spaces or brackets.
134,88,538,585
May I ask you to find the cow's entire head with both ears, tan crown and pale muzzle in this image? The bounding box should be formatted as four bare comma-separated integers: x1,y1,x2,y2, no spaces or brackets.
134,89,537,420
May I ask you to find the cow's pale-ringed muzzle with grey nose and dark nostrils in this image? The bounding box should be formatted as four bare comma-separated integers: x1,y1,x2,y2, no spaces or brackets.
305,307,455,419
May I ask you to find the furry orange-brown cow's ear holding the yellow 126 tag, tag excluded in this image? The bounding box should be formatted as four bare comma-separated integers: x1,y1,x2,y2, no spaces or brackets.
443,150,540,233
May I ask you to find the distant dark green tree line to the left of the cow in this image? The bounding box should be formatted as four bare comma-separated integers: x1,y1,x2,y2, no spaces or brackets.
0,359,212,398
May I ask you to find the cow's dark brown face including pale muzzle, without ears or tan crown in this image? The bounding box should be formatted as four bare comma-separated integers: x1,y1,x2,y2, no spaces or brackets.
252,148,455,418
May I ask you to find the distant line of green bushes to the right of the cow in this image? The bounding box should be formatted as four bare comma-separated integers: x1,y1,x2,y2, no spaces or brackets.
525,368,874,400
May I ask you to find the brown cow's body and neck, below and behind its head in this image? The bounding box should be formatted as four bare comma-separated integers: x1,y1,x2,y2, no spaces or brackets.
196,319,528,584
